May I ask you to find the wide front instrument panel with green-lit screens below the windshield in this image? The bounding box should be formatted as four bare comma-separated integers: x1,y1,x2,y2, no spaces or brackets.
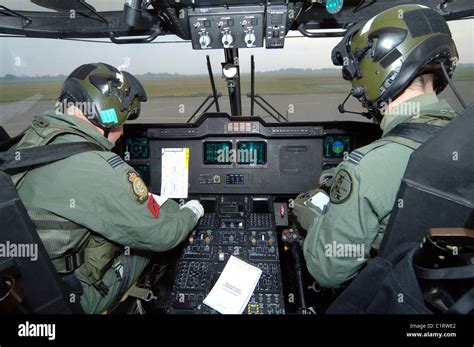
119,113,380,195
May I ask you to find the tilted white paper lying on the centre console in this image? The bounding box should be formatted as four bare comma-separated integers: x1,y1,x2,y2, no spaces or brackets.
204,256,262,314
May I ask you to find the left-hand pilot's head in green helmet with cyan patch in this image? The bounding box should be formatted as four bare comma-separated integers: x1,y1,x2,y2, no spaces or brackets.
55,63,147,142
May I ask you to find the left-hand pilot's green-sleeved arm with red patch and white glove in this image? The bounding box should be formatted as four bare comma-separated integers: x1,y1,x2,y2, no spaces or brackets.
87,153,203,252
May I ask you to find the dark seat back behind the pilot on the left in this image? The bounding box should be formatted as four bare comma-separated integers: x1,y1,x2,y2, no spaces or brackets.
0,171,75,314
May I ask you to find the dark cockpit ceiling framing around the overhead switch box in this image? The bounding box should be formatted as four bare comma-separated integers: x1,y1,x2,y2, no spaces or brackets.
0,0,474,43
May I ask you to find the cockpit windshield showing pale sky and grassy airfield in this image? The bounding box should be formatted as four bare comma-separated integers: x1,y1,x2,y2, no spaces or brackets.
0,19,474,136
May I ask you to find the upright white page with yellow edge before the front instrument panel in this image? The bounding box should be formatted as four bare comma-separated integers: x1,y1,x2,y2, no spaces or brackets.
161,148,189,199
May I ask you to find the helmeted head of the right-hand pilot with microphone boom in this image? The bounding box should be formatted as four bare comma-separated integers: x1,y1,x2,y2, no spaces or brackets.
332,5,458,118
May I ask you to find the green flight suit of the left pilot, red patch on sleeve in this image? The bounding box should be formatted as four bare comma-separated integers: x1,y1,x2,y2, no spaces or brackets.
11,112,197,313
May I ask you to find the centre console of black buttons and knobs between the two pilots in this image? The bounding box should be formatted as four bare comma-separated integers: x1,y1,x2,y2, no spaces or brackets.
167,196,285,314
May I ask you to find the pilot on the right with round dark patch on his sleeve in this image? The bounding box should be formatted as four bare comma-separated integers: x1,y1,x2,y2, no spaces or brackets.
293,5,458,287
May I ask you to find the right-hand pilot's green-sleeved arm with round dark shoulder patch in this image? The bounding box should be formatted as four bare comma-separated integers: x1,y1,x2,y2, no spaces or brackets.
294,145,406,288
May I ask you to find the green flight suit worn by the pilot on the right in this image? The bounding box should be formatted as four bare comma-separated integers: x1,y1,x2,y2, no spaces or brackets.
294,93,456,287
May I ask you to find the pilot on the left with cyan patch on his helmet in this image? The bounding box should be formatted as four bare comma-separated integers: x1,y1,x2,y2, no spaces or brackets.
12,63,204,313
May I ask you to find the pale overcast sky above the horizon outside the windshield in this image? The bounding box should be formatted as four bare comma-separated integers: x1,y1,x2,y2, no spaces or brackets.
0,19,474,76
